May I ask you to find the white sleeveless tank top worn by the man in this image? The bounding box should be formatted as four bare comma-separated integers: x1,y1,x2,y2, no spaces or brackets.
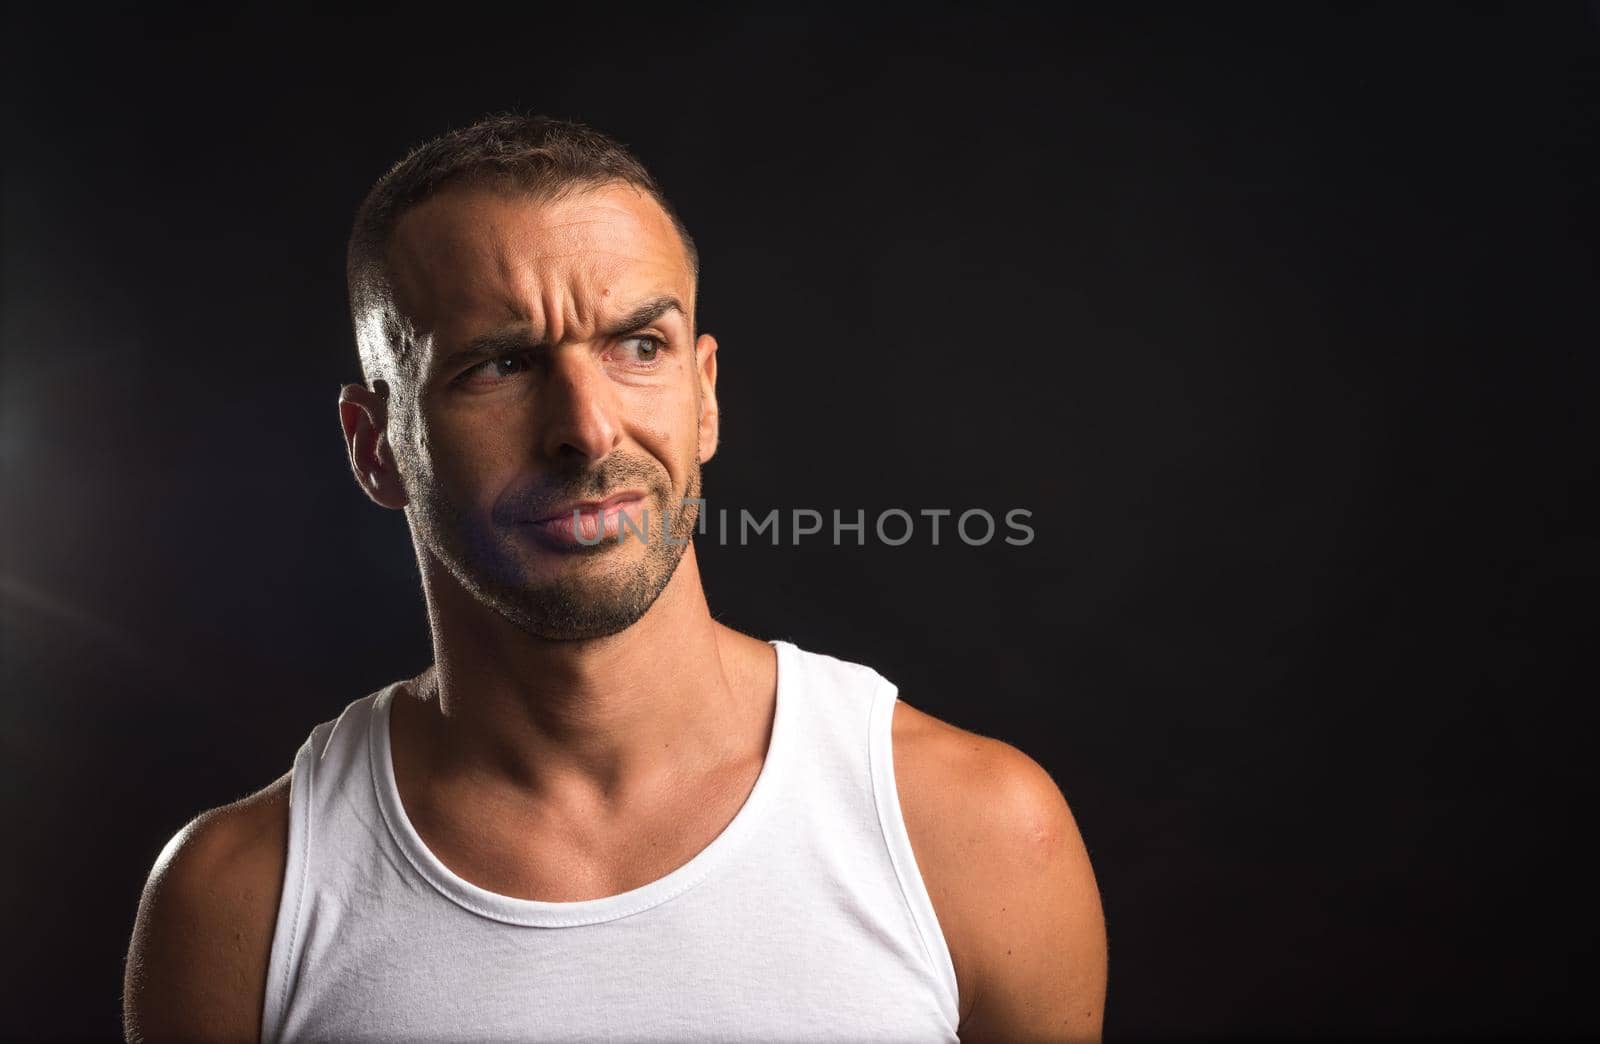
261,640,958,1042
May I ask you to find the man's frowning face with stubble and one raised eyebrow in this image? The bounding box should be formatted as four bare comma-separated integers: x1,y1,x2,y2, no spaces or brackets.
377,186,717,639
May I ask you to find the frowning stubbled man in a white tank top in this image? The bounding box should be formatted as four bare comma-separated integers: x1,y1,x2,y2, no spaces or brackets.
125,117,1106,1041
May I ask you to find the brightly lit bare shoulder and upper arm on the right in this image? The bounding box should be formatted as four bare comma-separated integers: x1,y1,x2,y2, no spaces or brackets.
894,703,1106,1042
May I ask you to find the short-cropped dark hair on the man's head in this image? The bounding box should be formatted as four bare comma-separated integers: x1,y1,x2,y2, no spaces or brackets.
346,114,699,375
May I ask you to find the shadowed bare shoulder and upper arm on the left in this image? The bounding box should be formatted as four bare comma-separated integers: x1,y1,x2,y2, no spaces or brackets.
123,775,288,1042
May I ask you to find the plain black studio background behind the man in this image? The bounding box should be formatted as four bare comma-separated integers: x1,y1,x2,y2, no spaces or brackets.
0,5,1600,1036
